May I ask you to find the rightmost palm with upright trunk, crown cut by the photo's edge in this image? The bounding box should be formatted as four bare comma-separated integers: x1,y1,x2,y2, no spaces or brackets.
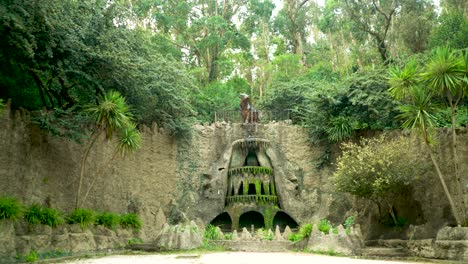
421,47,467,221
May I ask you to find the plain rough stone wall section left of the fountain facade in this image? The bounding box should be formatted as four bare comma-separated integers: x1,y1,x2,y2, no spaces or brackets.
0,109,178,240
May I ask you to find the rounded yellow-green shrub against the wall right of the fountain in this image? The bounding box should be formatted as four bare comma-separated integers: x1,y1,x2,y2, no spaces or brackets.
333,135,427,200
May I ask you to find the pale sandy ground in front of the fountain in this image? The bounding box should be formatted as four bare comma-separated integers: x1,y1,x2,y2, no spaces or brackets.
67,252,436,264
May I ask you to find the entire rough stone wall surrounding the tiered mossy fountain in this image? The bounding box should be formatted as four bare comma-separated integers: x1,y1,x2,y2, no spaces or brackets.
0,106,468,244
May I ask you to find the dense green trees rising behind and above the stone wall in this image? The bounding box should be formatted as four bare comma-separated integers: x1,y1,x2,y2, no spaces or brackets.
0,0,468,142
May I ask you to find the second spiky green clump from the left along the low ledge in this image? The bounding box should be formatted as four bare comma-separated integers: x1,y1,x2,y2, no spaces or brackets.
24,204,64,227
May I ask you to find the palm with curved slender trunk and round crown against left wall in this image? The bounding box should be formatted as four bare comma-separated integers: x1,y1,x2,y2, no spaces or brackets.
75,91,131,208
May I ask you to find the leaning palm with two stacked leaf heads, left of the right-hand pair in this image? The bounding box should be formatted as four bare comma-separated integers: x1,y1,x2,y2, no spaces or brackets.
389,62,461,225
